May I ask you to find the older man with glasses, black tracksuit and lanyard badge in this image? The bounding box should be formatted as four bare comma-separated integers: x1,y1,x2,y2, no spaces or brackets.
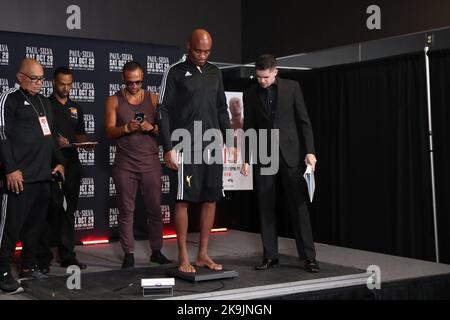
0,59,64,293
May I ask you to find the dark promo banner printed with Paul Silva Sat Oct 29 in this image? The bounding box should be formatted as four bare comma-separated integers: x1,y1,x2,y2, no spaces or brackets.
0,32,179,241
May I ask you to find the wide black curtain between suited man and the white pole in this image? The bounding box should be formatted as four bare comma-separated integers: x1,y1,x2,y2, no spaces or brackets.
223,53,442,260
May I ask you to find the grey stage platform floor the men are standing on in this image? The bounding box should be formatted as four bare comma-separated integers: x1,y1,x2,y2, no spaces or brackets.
0,230,450,300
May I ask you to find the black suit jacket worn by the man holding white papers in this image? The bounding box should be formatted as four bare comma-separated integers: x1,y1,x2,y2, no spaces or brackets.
243,78,314,167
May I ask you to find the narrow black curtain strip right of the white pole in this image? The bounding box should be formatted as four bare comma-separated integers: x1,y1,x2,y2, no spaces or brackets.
429,50,450,263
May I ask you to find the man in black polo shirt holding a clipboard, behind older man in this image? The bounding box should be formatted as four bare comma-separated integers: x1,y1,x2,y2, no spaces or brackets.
38,67,87,274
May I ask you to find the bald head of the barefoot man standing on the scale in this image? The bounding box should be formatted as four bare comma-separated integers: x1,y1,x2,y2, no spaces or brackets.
186,29,212,66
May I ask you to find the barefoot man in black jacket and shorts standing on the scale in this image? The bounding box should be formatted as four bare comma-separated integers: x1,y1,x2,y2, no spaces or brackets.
158,29,230,272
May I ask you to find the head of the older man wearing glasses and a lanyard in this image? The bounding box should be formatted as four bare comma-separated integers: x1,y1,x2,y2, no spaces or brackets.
16,58,44,95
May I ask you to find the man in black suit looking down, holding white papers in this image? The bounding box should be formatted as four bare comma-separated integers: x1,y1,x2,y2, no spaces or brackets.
241,54,319,272
